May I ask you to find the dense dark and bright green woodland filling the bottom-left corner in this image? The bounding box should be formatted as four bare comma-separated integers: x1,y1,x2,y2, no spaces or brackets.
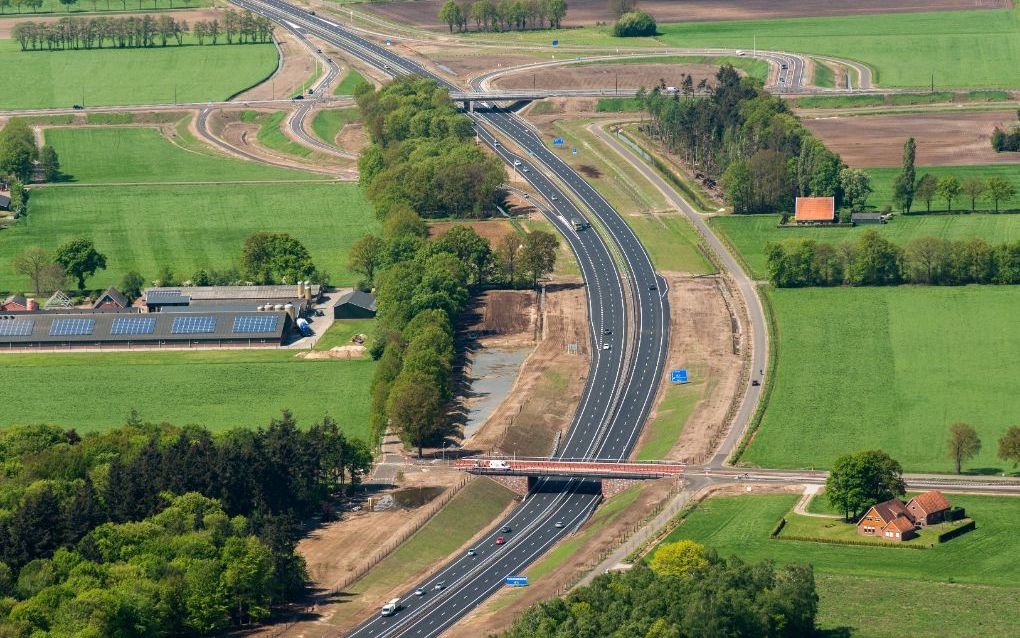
0,412,371,638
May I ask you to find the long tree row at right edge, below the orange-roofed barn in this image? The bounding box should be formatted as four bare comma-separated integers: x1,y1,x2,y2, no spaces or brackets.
765,230,1020,288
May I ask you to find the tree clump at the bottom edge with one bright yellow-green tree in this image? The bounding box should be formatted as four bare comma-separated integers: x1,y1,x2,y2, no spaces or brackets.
501,541,818,638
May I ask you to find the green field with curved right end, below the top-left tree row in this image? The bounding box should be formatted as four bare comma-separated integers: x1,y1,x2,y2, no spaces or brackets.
0,40,277,108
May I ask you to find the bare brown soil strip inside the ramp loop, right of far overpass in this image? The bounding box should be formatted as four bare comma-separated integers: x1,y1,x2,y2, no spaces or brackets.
493,62,726,90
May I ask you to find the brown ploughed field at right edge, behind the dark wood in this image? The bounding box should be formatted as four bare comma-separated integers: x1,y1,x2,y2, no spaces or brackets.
804,110,1020,167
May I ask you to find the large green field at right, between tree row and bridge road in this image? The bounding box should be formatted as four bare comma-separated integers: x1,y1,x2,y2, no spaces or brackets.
743,286,1020,473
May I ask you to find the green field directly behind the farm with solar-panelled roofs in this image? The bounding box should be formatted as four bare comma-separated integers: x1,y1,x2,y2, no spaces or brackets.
0,183,378,291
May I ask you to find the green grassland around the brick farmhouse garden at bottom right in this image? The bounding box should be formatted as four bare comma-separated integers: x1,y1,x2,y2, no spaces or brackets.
664,494,1020,638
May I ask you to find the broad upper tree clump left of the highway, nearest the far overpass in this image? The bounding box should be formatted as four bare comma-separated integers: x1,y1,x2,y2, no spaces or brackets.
354,76,506,218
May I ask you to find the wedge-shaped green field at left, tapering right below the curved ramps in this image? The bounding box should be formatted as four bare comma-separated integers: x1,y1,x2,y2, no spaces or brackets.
45,128,322,184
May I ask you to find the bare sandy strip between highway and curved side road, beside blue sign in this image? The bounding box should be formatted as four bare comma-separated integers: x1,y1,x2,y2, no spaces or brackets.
638,274,747,459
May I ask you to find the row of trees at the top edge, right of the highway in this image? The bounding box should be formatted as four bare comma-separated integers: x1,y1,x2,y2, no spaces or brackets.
440,0,567,33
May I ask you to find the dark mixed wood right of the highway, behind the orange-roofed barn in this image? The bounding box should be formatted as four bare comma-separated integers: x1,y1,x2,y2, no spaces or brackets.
638,64,846,213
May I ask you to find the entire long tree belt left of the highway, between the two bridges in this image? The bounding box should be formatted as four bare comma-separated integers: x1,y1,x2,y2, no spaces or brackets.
348,78,559,453
